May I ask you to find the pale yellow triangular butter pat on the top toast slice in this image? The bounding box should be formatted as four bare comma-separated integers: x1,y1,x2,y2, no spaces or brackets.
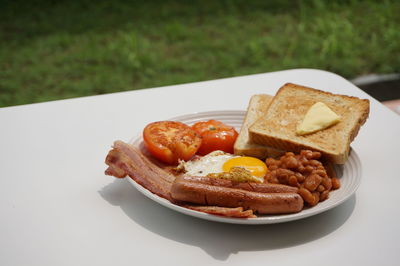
296,102,340,135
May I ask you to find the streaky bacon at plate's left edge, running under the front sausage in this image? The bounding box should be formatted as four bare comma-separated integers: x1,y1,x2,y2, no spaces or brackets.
105,140,256,218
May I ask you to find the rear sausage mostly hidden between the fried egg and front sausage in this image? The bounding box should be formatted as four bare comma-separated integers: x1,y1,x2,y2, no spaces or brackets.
176,176,298,193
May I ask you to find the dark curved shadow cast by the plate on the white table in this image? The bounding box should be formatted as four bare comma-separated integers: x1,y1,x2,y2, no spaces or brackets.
99,179,356,261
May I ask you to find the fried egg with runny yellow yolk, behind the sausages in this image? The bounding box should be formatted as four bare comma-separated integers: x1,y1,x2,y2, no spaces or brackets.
180,151,267,182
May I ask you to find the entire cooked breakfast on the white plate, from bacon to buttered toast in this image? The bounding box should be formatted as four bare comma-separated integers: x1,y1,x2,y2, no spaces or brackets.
106,84,369,218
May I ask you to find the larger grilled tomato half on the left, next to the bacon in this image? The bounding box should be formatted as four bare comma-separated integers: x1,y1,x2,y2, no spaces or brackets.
143,121,201,164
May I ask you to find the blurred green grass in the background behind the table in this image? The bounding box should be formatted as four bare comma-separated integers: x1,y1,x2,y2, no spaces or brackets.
0,0,400,106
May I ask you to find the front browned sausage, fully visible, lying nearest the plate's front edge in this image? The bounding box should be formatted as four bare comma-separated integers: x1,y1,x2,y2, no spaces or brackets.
171,179,303,214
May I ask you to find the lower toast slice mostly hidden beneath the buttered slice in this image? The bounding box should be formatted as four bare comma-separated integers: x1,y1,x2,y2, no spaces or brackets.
233,94,284,159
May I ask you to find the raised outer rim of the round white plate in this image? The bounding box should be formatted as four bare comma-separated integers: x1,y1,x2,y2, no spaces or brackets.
128,110,362,225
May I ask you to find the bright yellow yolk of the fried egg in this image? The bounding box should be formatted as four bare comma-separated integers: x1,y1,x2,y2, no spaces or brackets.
222,156,267,177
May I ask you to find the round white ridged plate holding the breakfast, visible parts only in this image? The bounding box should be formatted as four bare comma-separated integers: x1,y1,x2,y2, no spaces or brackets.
128,111,361,224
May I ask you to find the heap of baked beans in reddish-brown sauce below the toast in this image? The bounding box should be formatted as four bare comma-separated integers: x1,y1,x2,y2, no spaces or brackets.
265,150,340,206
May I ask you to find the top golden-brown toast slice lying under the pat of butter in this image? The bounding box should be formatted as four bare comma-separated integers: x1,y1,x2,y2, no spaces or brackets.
249,83,369,164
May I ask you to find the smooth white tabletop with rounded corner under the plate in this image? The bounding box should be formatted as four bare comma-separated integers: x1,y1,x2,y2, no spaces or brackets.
0,69,400,266
